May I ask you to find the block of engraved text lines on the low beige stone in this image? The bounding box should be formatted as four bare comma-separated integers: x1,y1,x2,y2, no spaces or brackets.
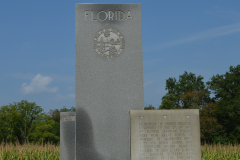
137,119,193,160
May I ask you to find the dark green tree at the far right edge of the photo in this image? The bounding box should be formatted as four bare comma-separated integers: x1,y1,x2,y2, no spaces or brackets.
207,65,240,143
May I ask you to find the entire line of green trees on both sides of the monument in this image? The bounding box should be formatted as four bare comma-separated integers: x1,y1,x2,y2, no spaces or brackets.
0,65,240,144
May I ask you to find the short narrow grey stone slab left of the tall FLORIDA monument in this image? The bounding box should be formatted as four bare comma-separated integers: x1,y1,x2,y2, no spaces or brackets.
60,112,75,160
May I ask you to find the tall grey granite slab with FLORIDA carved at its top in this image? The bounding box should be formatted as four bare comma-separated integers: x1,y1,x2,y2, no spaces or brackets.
75,4,144,160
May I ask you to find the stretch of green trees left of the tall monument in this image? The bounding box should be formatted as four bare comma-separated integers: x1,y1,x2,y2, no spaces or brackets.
0,100,75,144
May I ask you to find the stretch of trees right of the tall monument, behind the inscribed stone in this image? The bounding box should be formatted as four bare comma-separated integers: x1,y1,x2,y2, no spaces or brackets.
145,65,240,144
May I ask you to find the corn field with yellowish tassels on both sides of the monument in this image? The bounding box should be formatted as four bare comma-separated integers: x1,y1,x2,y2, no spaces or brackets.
0,144,240,160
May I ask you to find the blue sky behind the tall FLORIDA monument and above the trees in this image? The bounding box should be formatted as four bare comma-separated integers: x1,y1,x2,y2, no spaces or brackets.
0,0,240,112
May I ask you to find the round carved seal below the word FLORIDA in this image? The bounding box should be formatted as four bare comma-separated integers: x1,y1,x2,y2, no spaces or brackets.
94,28,124,59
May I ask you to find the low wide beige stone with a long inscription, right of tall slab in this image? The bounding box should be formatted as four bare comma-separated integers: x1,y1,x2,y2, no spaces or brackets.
130,109,201,160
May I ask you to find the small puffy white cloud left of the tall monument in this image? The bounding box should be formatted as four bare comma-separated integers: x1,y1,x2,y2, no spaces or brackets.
22,74,58,94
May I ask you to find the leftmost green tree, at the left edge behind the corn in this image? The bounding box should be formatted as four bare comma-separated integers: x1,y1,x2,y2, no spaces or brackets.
0,100,43,143
